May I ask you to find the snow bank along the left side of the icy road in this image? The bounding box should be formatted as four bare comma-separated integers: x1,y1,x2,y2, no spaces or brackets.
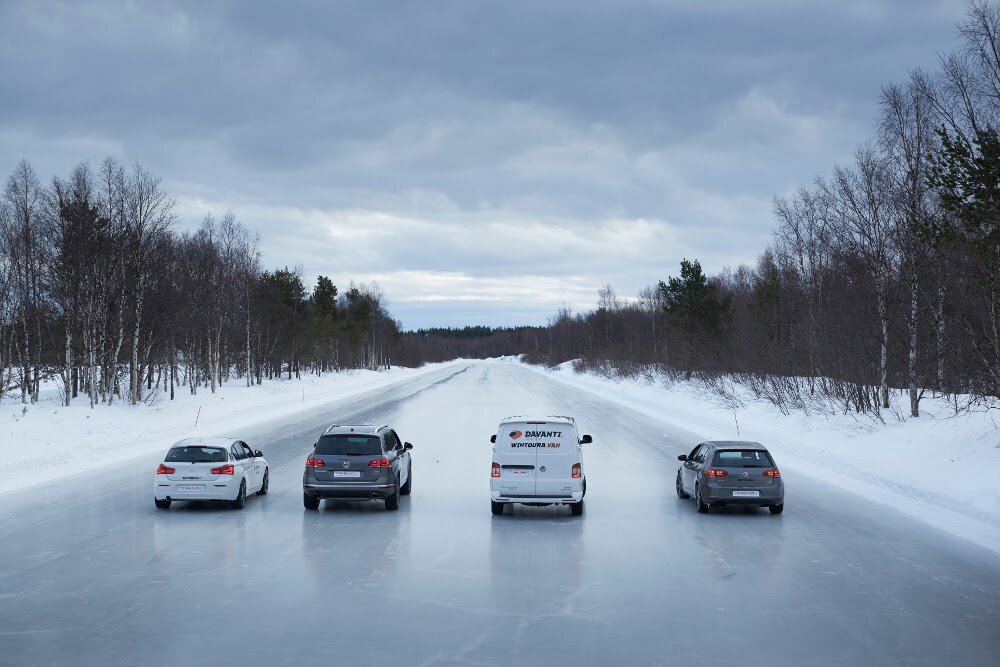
0,364,460,492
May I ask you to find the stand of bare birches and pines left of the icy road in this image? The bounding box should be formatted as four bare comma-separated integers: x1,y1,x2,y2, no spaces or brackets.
0,158,398,405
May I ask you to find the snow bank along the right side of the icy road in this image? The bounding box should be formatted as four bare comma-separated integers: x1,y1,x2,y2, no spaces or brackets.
525,363,1000,552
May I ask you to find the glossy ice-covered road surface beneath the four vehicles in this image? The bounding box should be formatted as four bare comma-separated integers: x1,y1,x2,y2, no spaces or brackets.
0,363,1000,665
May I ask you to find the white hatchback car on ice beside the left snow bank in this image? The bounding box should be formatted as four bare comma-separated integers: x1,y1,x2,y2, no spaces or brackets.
153,438,268,509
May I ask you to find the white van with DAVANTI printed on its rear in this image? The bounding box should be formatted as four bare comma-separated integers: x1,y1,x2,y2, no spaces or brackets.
490,417,593,516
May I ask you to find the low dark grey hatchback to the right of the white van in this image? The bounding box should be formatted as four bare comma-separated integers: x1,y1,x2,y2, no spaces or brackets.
676,440,785,514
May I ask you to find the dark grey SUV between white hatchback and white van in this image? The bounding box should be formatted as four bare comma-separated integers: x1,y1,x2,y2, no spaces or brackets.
302,424,413,510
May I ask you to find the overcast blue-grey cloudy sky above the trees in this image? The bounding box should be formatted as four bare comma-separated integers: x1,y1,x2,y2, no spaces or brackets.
0,0,965,329
